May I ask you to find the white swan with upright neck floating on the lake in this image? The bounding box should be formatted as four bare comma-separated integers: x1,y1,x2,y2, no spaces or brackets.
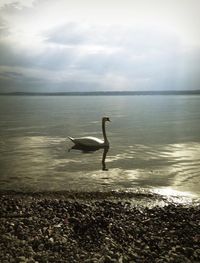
68,117,110,148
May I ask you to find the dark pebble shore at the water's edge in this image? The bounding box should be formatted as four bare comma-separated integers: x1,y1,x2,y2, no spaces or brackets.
0,193,200,263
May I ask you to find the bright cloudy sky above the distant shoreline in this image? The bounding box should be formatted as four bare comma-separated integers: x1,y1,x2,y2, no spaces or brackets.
0,0,200,92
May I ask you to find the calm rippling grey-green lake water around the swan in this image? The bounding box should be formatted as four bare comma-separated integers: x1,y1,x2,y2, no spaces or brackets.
0,95,200,199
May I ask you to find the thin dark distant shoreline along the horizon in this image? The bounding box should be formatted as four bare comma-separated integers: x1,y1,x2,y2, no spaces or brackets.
0,90,200,96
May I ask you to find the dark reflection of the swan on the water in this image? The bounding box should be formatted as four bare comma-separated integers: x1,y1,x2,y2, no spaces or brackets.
69,145,109,171
